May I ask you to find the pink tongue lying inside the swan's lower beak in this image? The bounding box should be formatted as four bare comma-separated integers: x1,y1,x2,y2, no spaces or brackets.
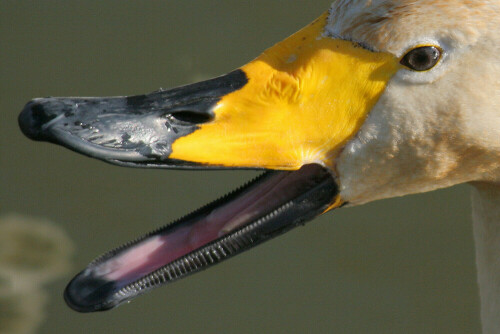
95,166,318,284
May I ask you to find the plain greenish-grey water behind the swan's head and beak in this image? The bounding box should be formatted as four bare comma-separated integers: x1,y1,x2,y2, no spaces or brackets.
0,0,480,333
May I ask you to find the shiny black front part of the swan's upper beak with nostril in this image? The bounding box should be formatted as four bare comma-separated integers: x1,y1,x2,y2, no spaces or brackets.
18,70,247,168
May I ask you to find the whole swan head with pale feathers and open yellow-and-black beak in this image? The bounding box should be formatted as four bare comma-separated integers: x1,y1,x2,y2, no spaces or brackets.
19,0,500,312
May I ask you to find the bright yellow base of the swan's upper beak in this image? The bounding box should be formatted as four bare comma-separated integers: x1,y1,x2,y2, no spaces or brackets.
170,13,400,170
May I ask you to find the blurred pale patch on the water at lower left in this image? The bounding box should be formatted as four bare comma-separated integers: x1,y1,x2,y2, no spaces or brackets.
0,214,73,334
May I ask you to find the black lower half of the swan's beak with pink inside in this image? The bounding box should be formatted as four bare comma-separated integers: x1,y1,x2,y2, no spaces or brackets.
65,164,336,312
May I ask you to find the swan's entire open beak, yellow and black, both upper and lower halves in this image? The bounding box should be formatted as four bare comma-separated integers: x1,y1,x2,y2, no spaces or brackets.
19,13,399,312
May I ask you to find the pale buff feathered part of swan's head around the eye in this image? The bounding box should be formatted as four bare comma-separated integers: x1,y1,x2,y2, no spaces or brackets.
326,0,500,204
